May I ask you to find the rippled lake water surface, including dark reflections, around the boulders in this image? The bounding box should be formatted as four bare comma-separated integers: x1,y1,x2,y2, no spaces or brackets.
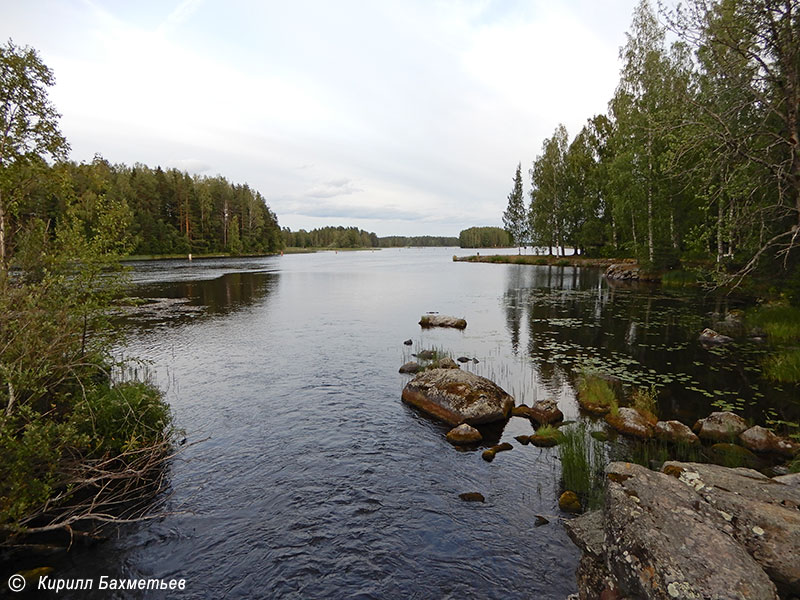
14,248,797,599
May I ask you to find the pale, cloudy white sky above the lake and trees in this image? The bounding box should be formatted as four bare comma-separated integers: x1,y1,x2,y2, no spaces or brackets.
0,0,636,236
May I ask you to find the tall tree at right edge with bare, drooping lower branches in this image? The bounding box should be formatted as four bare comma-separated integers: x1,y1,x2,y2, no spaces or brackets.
665,0,800,276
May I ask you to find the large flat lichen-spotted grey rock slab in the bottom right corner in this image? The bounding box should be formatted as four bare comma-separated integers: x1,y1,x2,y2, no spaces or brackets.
566,462,800,600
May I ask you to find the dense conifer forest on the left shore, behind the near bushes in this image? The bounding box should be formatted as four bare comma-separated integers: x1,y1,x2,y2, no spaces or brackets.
14,157,281,254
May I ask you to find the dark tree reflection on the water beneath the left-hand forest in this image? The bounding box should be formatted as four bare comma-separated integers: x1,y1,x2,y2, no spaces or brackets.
124,272,278,324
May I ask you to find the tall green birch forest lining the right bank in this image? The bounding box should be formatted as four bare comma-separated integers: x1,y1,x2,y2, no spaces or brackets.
503,0,800,288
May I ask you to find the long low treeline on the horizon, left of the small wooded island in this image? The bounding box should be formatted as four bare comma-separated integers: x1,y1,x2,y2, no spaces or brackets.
281,226,458,248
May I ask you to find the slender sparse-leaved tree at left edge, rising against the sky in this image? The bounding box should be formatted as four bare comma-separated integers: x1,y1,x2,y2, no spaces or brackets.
0,40,68,270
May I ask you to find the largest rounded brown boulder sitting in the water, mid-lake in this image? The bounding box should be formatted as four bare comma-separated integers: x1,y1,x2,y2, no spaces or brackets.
403,369,514,425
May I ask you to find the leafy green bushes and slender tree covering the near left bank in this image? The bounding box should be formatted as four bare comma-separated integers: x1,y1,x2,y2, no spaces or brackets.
0,42,171,545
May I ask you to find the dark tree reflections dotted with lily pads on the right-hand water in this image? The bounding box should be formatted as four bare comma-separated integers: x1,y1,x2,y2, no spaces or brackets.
506,267,785,422
